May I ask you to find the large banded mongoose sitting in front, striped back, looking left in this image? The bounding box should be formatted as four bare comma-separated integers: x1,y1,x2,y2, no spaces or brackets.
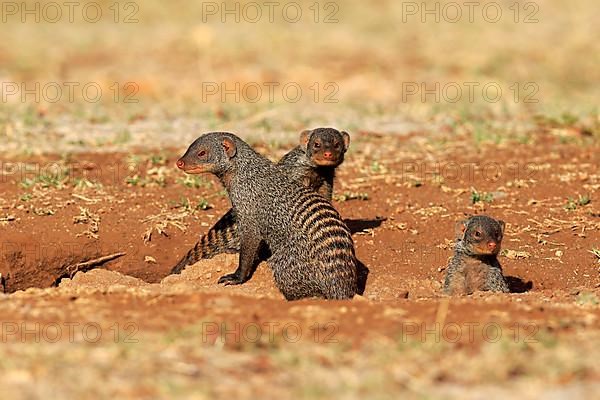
177,132,357,300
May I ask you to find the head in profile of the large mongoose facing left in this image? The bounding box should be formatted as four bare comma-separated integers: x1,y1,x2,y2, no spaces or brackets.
176,132,241,176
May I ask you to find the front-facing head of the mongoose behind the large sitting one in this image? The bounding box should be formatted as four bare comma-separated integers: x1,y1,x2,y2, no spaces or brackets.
300,128,350,167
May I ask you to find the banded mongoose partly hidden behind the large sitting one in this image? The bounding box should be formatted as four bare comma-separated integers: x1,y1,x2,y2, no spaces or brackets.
171,128,350,274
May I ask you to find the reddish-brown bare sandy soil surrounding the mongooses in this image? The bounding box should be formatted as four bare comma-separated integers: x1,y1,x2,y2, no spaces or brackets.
0,133,600,342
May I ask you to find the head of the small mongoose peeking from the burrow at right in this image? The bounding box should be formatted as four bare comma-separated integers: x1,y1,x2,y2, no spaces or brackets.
456,215,505,255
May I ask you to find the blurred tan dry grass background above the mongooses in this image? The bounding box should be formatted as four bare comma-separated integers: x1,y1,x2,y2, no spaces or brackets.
0,0,600,153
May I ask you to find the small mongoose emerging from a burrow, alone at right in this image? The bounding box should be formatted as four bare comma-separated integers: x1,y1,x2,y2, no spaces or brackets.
444,215,509,295
